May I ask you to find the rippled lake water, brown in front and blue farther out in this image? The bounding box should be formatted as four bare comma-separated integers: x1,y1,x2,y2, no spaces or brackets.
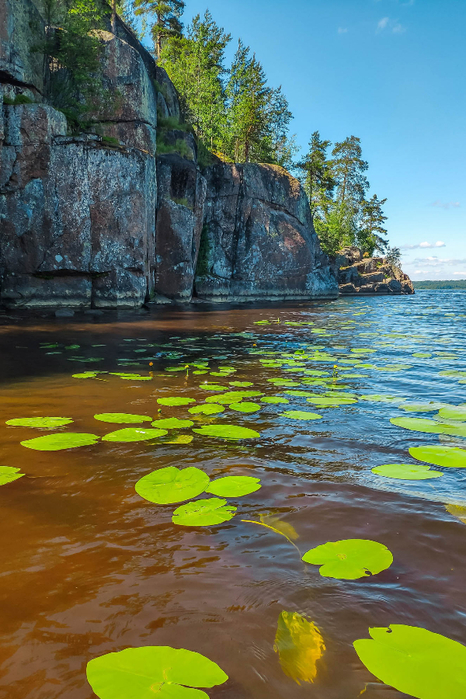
0,291,466,699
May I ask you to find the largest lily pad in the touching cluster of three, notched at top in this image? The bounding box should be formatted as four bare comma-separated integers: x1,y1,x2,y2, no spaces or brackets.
134,466,209,505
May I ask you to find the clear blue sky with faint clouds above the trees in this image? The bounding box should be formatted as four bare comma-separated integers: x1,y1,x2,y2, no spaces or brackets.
151,0,466,279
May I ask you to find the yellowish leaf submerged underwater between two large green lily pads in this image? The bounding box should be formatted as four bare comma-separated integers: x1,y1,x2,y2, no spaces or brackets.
274,611,325,684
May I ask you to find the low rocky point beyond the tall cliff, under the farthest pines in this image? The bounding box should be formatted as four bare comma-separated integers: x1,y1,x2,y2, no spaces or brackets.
336,247,414,295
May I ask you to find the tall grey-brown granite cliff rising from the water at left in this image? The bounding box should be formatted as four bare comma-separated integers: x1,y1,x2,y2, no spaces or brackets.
0,0,338,308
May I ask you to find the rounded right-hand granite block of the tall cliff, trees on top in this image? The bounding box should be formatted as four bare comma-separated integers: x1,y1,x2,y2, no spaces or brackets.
195,163,338,301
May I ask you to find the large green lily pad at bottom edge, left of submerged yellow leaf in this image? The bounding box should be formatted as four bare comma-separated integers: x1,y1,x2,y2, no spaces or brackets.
86,646,228,699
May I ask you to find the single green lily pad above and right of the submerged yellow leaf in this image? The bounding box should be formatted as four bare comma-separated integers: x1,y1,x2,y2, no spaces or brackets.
303,539,393,580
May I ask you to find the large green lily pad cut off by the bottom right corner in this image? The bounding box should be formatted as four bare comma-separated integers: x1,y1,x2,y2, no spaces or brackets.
353,624,466,699
